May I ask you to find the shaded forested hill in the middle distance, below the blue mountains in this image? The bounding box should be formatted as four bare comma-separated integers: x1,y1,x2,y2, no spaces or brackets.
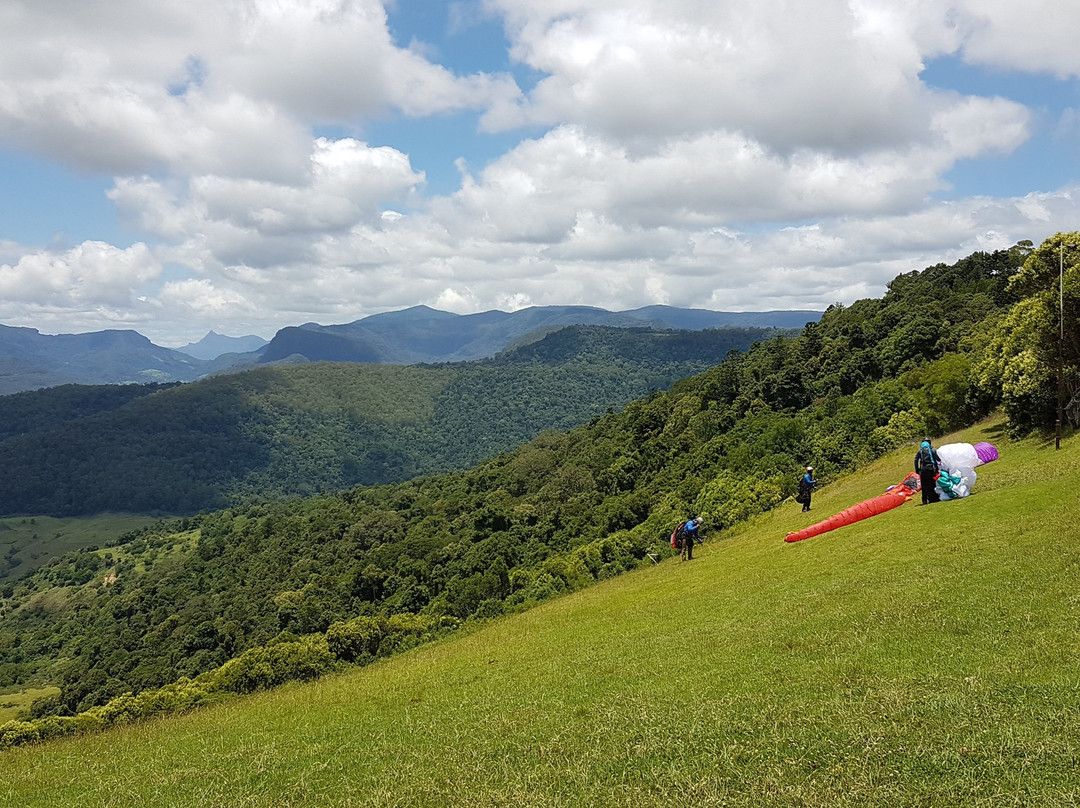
0,326,780,515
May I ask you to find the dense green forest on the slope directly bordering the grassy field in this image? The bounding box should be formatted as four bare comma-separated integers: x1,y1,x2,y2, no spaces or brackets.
0,234,1080,730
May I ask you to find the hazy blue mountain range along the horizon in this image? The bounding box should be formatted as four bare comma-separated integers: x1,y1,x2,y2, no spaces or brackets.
0,306,821,395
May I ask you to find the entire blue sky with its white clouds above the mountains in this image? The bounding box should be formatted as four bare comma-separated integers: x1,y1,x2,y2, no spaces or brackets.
0,0,1080,347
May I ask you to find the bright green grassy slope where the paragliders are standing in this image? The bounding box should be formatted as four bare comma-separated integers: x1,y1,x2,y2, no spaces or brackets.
0,426,1080,808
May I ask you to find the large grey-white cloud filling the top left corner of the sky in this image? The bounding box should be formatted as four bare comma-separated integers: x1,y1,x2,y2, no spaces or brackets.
0,0,516,181
